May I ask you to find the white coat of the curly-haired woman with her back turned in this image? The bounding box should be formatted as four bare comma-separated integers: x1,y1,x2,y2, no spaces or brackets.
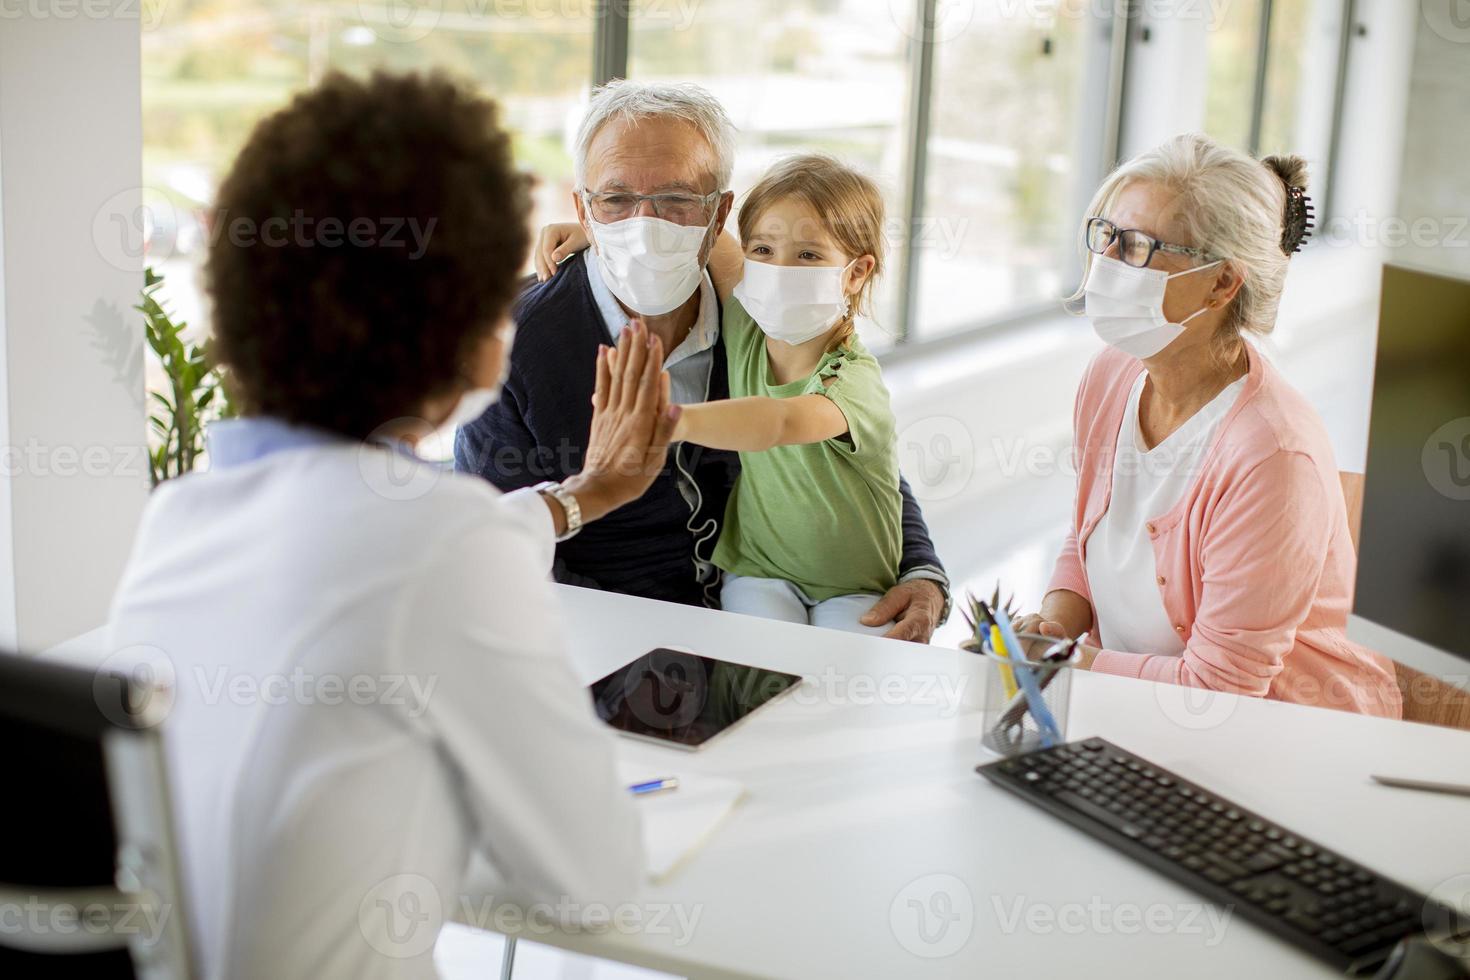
110,426,642,980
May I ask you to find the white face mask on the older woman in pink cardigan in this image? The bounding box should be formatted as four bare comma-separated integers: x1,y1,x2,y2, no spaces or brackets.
1082,256,1225,360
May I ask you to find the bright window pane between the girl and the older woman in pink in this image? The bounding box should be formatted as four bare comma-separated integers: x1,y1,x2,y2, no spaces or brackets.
908,0,1100,341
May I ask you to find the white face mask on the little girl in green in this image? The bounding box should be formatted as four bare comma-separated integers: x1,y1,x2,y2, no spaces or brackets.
735,259,853,344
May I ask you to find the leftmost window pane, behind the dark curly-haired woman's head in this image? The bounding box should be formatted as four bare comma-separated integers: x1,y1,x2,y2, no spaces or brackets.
143,0,594,323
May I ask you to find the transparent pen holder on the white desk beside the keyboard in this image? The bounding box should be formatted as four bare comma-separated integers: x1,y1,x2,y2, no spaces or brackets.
964,633,1073,757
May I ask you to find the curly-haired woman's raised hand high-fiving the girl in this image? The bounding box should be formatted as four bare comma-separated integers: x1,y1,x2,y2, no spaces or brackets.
563,320,679,522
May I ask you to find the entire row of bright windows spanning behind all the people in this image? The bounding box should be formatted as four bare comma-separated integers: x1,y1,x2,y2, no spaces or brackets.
143,0,1345,348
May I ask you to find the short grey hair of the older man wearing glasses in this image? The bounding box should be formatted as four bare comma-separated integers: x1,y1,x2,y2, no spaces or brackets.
572,78,735,191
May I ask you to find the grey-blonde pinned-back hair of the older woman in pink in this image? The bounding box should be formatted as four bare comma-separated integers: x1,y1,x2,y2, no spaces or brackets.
1072,132,1307,341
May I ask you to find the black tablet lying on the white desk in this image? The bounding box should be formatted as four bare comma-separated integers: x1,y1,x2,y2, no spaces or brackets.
591,646,801,748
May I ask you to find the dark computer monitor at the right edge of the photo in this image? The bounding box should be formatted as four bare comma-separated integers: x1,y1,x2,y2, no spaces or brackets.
1354,266,1470,658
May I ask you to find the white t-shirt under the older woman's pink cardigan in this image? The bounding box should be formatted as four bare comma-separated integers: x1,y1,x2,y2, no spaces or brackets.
1086,372,1245,657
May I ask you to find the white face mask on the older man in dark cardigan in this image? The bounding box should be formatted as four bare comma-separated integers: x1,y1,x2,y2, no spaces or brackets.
592,217,710,316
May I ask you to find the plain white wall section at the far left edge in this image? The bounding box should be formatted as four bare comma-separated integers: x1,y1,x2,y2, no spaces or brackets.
0,3,147,651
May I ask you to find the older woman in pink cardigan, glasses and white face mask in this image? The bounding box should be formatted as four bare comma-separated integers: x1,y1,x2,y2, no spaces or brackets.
1025,135,1401,717
